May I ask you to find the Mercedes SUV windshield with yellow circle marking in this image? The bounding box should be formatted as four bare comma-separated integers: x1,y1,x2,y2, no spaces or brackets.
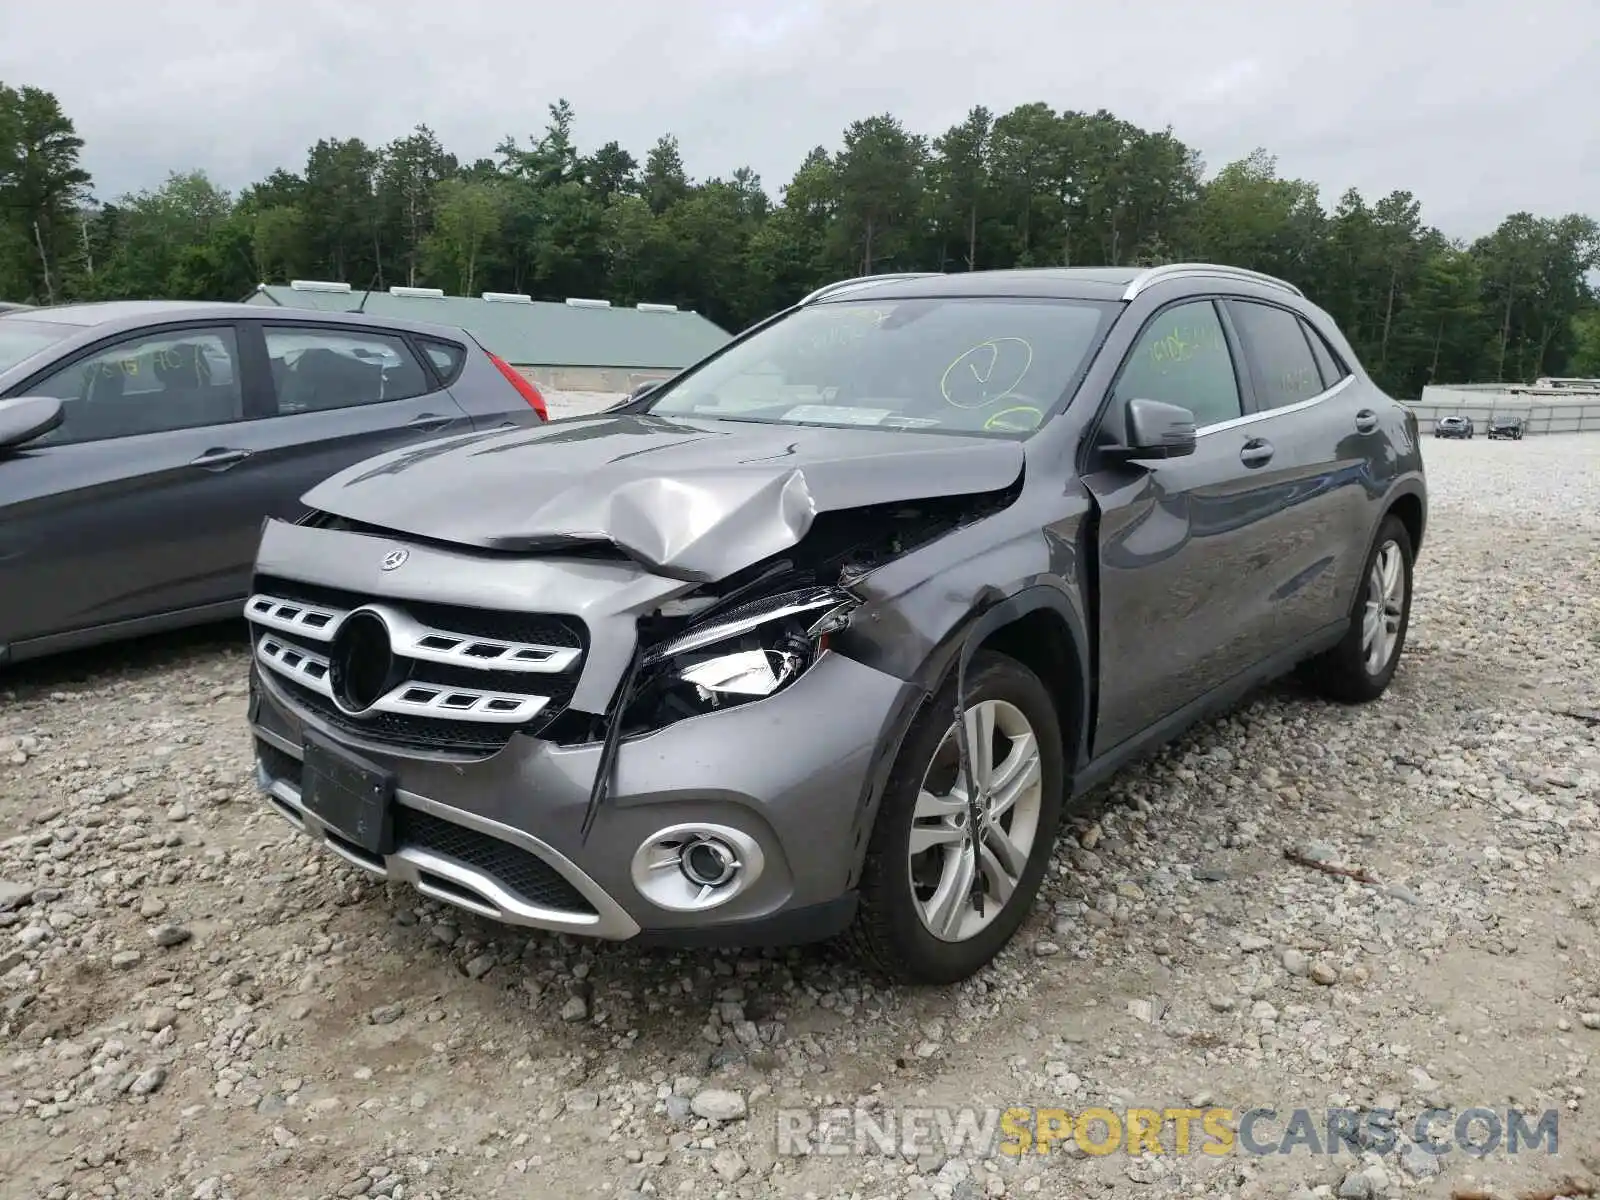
648,298,1115,438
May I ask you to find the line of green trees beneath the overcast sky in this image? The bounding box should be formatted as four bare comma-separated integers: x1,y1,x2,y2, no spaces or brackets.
0,83,1600,397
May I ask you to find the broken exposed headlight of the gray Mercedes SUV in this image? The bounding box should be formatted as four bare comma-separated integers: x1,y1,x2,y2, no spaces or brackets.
624,587,854,731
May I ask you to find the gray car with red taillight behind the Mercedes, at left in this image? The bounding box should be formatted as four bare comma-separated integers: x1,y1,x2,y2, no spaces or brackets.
0,301,547,662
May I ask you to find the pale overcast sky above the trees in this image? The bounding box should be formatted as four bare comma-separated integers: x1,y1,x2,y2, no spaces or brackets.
0,0,1600,237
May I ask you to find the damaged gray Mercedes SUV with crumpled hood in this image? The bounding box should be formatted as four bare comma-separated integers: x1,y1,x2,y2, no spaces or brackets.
246,264,1427,982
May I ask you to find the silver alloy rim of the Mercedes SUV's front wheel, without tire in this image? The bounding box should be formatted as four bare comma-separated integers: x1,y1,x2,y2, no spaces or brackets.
909,699,1043,942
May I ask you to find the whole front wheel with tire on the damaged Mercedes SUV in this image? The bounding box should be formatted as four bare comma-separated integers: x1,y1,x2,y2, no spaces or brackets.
851,651,1066,984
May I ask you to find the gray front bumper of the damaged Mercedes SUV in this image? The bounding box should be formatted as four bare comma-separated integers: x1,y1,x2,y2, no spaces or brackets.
251,653,918,944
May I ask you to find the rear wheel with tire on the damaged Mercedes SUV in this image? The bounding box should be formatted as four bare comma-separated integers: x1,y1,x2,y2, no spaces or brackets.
1306,517,1414,704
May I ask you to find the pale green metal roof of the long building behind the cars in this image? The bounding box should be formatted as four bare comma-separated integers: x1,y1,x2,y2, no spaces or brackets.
246,283,731,370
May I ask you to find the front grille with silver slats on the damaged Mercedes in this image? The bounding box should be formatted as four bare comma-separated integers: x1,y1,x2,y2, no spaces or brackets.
245,576,587,757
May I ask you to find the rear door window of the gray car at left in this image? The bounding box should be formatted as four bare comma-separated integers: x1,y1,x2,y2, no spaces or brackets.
262,325,434,414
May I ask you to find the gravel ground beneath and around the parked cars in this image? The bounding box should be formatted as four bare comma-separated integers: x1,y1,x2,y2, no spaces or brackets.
0,437,1600,1200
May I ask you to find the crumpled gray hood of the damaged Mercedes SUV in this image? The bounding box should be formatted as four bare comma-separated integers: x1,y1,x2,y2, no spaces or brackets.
302,414,1024,581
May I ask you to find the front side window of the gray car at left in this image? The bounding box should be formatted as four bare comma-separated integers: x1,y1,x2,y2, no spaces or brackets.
27,328,245,445
